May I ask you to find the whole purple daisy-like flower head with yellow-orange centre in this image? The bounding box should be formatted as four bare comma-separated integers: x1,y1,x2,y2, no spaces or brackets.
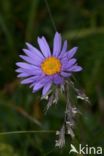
16,32,82,96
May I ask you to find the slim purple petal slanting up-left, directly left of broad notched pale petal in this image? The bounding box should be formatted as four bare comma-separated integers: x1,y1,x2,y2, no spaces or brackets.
26,43,44,59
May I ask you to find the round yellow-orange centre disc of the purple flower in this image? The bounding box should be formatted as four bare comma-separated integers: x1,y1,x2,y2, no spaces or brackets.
41,56,61,75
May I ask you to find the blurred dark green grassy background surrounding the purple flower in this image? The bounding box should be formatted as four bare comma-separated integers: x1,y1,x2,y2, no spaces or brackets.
0,0,104,156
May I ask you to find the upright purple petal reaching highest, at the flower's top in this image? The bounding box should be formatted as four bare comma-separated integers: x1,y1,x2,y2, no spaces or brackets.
53,32,62,57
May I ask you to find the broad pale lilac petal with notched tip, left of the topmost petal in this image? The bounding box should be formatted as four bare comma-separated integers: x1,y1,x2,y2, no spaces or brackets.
38,37,51,57
